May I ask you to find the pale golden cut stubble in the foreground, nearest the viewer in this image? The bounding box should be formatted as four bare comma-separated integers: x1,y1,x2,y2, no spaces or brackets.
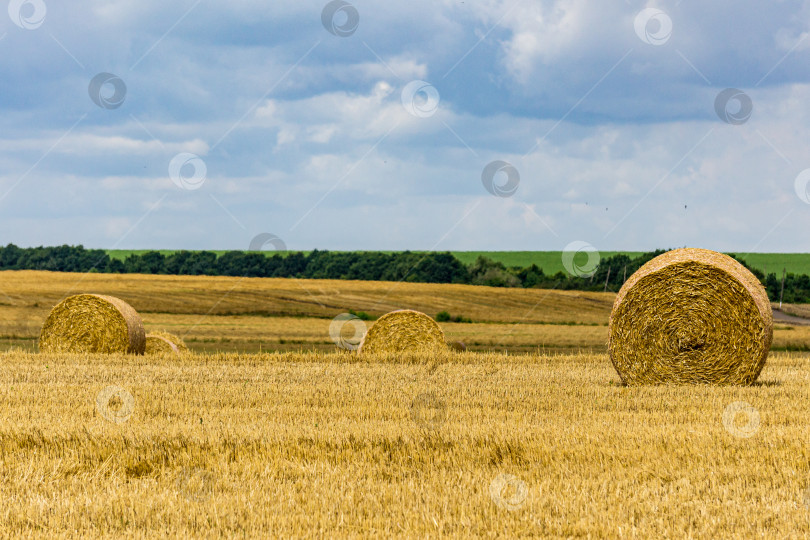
0,353,810,538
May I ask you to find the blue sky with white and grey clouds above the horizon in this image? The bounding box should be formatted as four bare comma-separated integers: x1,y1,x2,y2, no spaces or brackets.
0,0,810,253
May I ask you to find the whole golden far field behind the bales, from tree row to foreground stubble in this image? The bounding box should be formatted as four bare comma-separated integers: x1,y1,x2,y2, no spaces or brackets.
0,271,810,353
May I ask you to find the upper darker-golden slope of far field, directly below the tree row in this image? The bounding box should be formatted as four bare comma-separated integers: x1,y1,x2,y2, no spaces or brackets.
0,270,614,324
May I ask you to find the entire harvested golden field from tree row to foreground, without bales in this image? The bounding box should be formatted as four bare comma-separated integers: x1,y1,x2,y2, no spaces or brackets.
0,272,810,538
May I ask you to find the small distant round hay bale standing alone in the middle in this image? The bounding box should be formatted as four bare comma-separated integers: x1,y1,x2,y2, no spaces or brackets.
359,309,447,353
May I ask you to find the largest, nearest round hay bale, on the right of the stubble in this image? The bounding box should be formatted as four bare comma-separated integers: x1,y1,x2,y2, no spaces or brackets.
608,248,773,385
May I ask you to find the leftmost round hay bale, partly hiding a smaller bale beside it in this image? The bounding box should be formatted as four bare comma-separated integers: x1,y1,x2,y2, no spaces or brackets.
39,294,146,354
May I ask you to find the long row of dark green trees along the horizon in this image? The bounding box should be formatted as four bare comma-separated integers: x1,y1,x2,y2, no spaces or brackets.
0,244,810,303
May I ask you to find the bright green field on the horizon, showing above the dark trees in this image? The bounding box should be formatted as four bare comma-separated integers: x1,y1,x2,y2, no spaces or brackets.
107,249,810,275
